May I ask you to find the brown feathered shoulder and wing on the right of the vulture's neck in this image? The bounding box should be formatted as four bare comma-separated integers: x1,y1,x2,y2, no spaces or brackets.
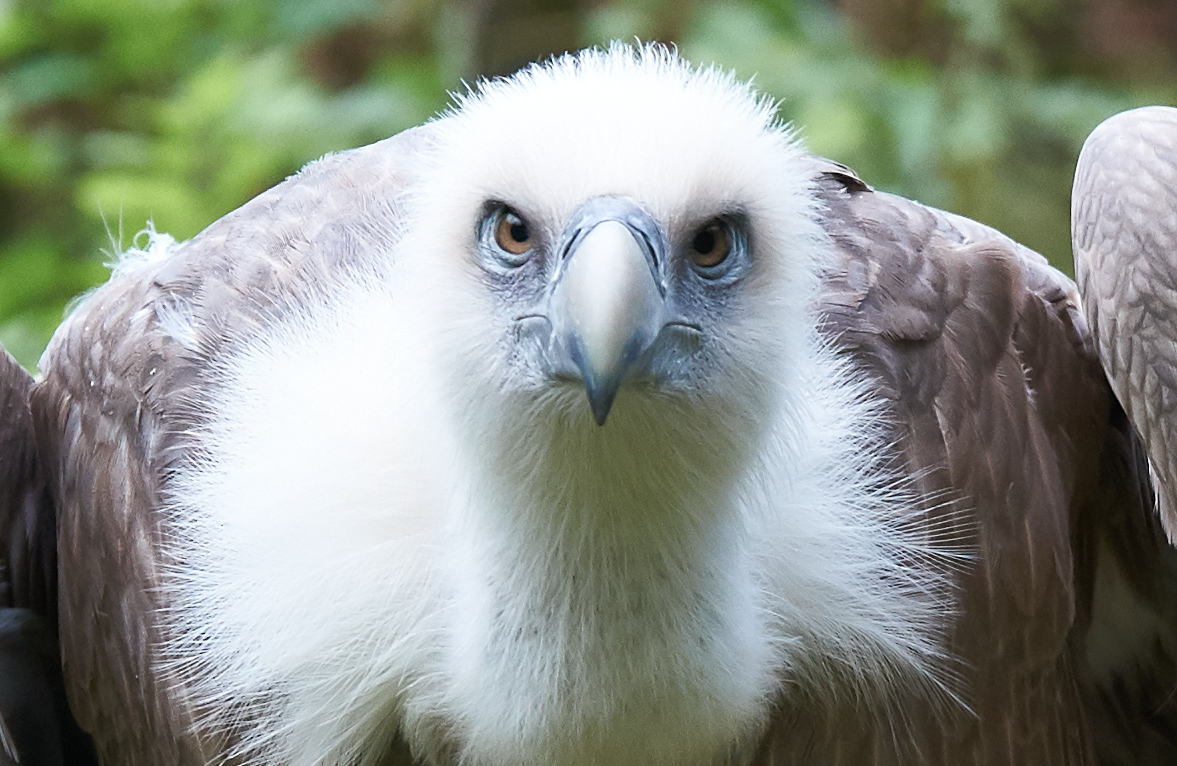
759,158,1172,765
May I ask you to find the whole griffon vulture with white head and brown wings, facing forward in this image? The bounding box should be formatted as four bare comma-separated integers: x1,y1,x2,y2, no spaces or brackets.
4,46,1177,766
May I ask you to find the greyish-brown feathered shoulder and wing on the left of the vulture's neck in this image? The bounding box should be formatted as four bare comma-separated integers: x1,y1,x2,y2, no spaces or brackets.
33,124,428,766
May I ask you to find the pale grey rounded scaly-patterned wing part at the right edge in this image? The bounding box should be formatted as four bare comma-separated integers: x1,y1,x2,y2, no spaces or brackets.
1071,106,1177,540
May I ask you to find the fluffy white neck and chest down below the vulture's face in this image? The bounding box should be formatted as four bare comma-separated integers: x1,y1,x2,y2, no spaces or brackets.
158,274,942,766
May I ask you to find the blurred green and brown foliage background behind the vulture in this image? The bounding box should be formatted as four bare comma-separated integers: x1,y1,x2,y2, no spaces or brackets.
0,0,1177,367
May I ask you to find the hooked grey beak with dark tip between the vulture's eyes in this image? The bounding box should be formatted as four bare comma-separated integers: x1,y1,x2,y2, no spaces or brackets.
548,198,665,426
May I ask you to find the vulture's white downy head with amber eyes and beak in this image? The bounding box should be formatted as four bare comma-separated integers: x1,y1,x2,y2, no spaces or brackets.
419,51,822,440
